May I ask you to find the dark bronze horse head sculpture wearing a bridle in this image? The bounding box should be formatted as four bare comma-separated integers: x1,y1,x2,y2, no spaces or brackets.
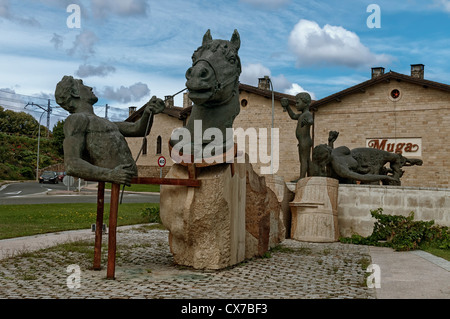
170,30,242,164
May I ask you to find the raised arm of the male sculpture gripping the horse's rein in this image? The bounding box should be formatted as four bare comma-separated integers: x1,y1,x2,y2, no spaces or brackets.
115,96,165,137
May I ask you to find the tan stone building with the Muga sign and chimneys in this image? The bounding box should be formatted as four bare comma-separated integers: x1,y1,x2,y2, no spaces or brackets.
127,64,450,188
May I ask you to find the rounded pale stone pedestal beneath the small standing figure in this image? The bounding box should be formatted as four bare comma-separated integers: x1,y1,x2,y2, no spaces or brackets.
289,177,339,242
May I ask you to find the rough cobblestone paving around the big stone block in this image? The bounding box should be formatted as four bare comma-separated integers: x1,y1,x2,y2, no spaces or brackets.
0,226,376,299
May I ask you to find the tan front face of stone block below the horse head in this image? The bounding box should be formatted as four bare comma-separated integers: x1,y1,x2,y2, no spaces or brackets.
160,163,246,269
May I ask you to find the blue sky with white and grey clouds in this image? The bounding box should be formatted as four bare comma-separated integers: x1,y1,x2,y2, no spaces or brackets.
0,0,450,128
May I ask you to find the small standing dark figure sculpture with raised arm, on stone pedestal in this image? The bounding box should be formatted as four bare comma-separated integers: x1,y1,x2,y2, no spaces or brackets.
281,92,314,183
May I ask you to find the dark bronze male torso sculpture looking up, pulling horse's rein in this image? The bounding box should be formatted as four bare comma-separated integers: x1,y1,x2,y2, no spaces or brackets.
55,76,164,185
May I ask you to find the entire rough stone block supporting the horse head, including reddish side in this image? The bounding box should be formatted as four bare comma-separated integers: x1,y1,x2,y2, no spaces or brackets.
160,155,287,269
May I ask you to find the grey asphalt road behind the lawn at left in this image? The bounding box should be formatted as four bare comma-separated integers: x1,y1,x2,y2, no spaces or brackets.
0,182,159,206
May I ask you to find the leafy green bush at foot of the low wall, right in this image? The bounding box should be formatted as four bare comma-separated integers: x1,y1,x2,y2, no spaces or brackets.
340,208,450,251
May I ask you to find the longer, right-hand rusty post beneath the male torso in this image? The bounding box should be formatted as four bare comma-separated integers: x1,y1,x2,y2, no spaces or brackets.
106,183,120,279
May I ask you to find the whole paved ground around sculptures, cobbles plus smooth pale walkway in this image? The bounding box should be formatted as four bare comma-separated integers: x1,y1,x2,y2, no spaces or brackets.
0,225,450,299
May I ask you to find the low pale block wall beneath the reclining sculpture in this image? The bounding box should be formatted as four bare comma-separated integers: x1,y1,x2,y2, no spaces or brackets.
338,184,450,237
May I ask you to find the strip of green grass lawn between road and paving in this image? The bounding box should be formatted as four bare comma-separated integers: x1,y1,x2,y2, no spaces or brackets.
0,203,159,239
